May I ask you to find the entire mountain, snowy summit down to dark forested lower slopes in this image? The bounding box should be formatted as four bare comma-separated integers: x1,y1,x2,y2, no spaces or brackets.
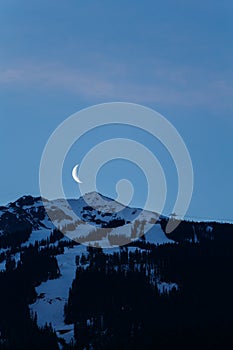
0,192,233,350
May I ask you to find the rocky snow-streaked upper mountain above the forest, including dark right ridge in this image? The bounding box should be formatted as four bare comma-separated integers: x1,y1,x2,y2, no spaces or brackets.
0,192,226,248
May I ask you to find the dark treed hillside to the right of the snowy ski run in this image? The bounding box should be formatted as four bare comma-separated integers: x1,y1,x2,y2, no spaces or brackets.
65,241,233,349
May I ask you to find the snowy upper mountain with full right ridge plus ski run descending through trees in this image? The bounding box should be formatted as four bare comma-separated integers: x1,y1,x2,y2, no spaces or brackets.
0,192,232,349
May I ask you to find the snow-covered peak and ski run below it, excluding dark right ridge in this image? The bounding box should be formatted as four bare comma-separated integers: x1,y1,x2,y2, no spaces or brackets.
0,192,174,342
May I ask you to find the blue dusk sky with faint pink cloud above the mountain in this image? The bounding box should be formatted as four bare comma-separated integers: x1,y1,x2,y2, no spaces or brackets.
0,0,233,220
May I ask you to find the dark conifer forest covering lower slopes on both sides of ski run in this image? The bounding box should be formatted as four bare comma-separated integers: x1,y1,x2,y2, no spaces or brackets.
0,222,233,350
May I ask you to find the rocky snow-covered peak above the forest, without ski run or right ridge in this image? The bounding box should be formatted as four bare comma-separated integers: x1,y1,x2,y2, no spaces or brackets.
0,192,171,248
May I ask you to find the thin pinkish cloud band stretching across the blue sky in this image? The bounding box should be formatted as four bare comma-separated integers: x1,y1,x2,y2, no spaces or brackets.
0,60,233,107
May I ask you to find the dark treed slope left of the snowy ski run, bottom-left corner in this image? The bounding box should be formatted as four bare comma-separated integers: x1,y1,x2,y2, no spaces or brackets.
0,245,59,350
